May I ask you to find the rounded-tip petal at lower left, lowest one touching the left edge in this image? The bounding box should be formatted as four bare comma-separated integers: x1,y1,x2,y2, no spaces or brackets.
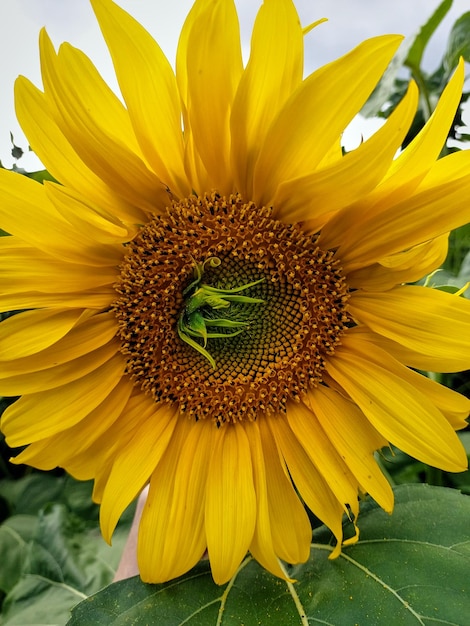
1,355,125,448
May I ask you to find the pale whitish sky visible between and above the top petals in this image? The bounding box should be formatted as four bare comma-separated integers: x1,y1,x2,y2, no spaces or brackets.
0,0,469,169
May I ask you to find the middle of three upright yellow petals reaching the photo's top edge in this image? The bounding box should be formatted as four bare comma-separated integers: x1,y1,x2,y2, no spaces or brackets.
178,0,242,194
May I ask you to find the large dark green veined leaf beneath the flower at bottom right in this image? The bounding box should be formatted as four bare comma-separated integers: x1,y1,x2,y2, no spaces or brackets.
68,485,470,626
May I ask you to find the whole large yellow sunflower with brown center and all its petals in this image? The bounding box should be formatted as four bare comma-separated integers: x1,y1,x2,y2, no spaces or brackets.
0,0,470,583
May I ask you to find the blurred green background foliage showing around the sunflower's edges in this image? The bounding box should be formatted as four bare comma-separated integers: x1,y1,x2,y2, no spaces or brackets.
0,0,470,626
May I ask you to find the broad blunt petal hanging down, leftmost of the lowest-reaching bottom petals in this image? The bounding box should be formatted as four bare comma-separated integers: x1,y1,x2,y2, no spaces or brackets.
138,416,211,582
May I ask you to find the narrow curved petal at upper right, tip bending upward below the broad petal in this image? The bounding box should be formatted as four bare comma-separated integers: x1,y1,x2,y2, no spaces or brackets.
273,83,418,222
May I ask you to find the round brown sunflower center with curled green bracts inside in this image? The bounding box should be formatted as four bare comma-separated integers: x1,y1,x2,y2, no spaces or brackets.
113,194,349,423
